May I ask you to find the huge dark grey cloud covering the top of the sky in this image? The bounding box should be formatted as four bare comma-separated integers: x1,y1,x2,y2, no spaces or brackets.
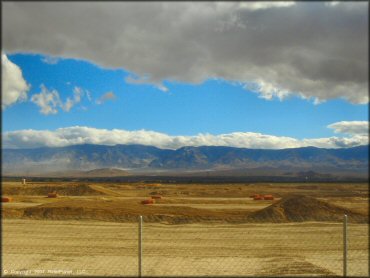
3,1,369,104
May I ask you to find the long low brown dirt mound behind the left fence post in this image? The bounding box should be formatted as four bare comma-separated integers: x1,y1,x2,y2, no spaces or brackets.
14,199,243,224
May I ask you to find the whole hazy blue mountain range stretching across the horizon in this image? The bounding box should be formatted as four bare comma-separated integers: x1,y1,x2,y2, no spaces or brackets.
2,144,369,176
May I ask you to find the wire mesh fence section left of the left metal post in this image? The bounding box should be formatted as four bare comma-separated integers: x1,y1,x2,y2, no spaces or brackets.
2,220,138,277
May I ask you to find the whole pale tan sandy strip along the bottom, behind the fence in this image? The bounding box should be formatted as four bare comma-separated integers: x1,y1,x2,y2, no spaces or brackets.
2,219,369,277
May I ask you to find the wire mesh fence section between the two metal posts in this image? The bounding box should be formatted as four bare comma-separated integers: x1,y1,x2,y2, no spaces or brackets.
143,223,343,276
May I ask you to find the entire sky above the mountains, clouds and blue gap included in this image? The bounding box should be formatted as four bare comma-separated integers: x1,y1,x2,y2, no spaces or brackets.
1,2,369,149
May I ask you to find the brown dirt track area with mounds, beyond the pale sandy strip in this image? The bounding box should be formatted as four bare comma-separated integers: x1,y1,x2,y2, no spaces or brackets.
2,182,368,224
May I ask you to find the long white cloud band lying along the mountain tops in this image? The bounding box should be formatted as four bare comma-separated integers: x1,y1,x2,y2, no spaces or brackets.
3,126,368,149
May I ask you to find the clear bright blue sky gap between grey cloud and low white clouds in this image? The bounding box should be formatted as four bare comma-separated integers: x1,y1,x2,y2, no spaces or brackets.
3,54,368,139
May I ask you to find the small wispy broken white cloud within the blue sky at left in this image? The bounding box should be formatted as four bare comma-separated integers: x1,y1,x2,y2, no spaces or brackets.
31,84,84,115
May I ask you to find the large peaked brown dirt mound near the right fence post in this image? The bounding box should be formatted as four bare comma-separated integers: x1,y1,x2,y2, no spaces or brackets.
247,195,368,223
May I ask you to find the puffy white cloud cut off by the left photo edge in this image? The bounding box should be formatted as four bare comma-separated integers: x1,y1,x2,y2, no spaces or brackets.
1,54,30,110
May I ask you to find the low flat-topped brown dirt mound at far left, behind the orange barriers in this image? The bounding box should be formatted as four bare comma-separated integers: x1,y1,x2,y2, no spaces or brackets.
3,184,105,196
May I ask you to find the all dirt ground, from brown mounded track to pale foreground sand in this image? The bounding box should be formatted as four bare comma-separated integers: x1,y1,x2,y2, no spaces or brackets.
2,182,369,276
